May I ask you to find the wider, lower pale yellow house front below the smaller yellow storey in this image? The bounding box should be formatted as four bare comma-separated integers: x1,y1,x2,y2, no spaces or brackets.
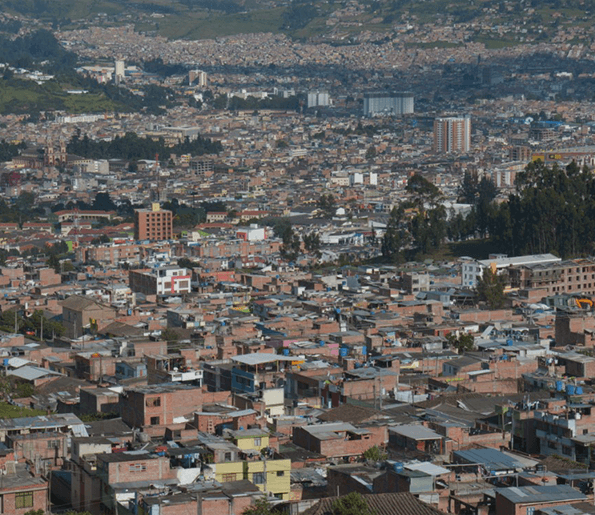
211,459,291,500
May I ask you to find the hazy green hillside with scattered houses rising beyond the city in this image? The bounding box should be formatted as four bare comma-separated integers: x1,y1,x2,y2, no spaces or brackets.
0,0,595,41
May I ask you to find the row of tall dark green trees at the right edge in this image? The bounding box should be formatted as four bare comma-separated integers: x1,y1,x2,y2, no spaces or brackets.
381,161,595,262
